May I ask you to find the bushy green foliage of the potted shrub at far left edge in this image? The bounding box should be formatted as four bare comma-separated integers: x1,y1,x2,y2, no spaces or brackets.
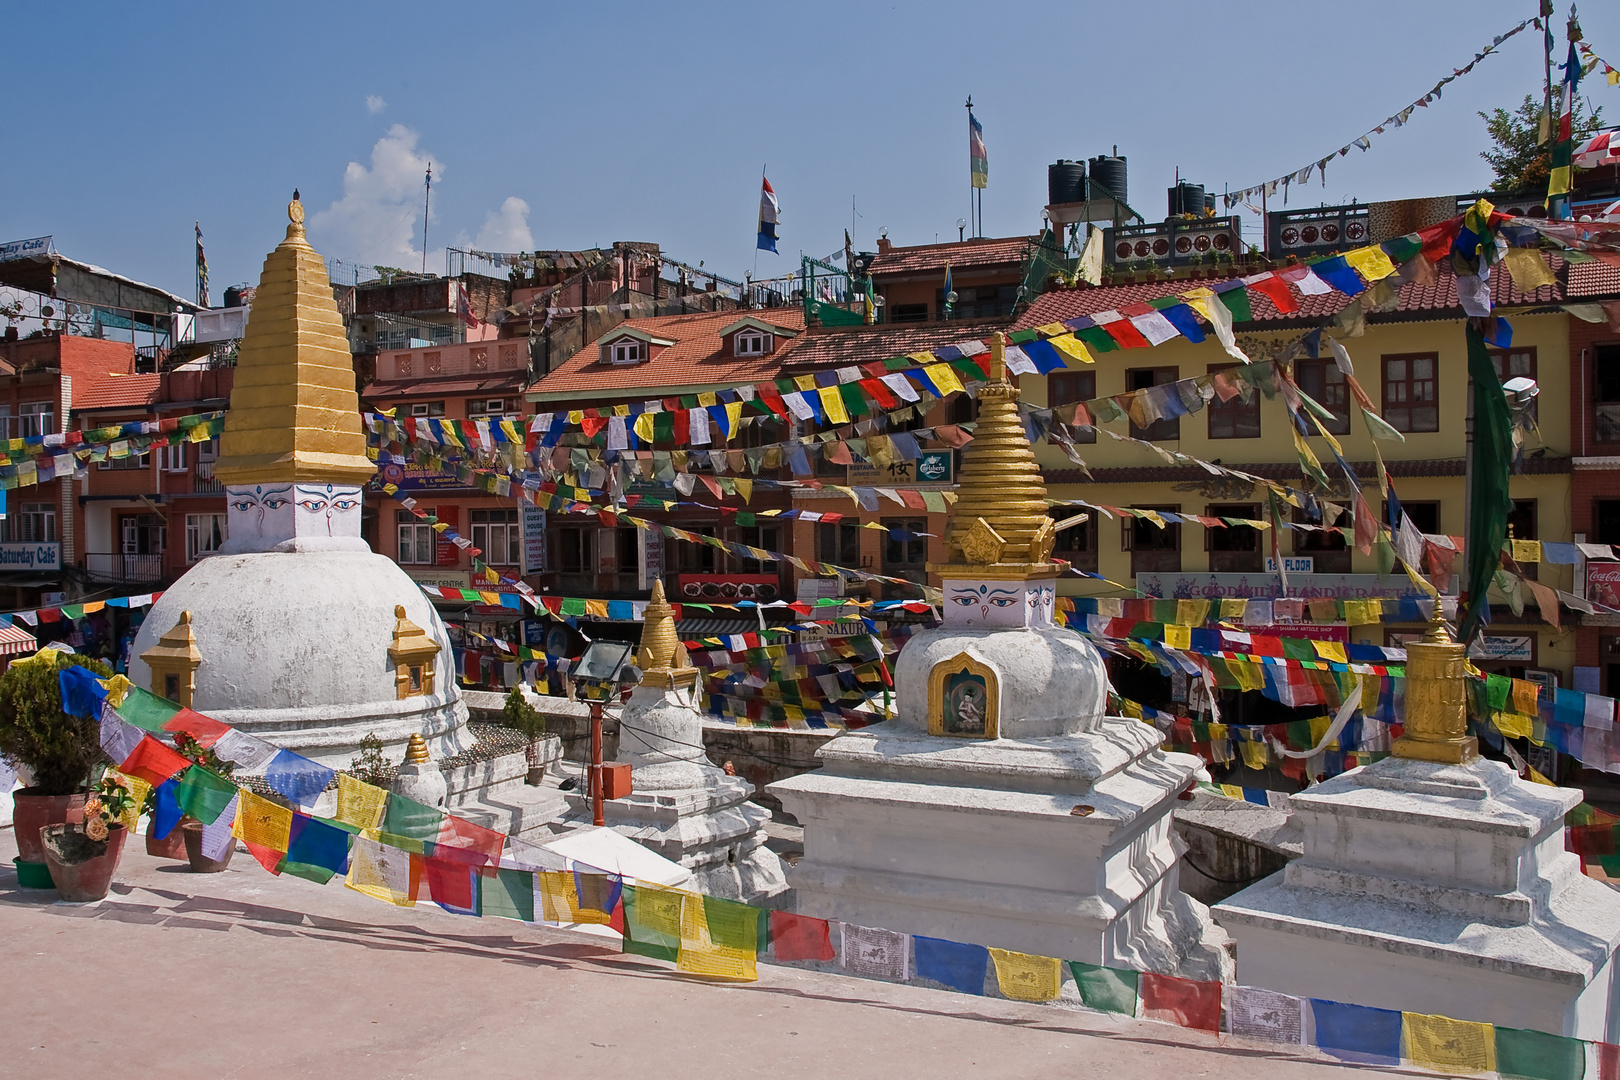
0,653,112,795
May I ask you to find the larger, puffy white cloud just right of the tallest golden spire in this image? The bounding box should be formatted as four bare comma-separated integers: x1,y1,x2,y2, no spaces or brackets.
309,123,437,269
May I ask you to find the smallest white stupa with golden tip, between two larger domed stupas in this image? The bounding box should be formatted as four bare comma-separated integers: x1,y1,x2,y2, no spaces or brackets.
564,581,787,904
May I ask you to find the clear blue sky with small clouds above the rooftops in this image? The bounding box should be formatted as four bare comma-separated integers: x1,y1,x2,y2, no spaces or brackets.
0,0,1620,303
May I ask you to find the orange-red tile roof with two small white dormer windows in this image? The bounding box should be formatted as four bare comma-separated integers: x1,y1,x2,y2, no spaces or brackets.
528,308,805,400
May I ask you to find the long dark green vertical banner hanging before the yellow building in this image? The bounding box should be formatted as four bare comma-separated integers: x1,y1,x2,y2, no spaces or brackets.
1460,319,1513,643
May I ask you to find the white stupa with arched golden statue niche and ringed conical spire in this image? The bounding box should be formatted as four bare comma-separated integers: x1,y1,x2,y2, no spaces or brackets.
771,335,1226,980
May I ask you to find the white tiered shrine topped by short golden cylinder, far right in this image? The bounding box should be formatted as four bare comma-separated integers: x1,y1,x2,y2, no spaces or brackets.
1215,615,1620,1043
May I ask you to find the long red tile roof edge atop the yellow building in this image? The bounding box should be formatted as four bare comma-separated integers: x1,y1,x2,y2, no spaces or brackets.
1014,254,1565,330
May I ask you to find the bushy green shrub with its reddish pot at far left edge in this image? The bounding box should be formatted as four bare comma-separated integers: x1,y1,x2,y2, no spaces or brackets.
0,649,112,889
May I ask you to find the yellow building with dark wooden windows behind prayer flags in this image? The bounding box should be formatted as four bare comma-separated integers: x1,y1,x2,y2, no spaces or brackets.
1016,255,1580,687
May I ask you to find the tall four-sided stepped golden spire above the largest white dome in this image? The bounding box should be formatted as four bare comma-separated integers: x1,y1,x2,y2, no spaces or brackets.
214,193,376,486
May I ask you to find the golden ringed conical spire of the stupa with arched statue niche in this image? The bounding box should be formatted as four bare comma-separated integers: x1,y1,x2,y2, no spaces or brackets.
930,334,1056,576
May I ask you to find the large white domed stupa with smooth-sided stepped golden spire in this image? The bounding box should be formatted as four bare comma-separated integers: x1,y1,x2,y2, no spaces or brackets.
130,193,471,767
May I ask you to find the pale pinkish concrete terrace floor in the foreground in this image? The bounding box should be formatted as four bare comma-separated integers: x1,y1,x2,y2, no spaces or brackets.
0,829,1434,1080
